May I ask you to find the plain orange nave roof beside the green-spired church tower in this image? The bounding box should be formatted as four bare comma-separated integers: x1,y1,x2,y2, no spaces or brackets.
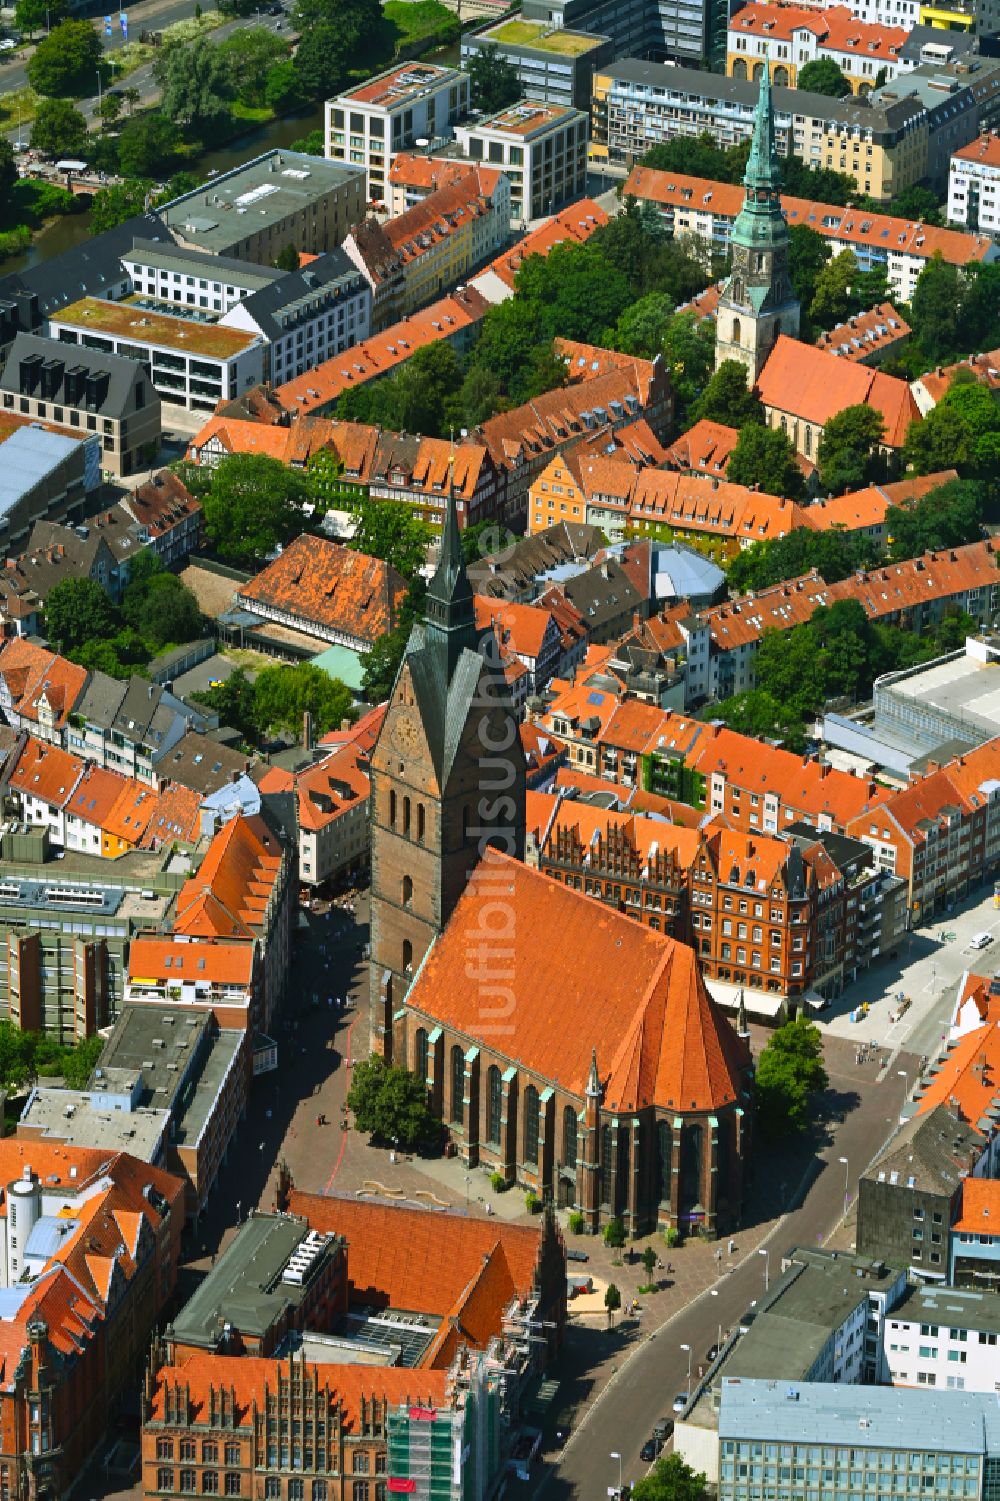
757,333,920,449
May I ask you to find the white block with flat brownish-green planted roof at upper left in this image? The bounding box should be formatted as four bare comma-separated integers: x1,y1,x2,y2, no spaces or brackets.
50,297,266,411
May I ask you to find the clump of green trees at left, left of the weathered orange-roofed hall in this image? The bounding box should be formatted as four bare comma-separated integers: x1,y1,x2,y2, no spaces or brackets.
45,548,204,677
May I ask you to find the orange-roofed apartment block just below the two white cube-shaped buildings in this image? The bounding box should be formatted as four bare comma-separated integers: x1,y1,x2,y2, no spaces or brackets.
344,167,511,327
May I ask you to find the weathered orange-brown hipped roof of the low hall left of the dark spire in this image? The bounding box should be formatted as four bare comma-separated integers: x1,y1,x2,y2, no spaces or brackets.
237,531,407,644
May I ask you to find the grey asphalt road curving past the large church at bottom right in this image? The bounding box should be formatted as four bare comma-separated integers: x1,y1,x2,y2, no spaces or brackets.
536,1045,908,1501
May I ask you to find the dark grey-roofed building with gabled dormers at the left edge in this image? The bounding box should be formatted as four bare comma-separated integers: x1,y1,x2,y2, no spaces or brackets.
0,333,161,479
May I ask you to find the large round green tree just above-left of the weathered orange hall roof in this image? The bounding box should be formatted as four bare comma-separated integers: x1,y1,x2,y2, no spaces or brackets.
201,453,309,563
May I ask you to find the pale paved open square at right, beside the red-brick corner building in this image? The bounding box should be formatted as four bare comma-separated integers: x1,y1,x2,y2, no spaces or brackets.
823,886,1000,1057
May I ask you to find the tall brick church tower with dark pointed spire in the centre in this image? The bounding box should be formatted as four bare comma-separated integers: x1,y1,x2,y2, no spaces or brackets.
369,485,526,1058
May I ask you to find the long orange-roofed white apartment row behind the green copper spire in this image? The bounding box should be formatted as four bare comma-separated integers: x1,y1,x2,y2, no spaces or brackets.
625,167,1000,303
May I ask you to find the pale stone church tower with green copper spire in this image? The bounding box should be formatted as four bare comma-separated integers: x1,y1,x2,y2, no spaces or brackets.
715,69,799,386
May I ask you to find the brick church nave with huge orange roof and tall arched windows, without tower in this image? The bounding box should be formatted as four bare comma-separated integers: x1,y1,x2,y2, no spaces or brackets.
393,850,752,1234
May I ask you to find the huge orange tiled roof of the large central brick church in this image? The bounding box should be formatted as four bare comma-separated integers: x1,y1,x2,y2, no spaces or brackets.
407,851,749,1111
